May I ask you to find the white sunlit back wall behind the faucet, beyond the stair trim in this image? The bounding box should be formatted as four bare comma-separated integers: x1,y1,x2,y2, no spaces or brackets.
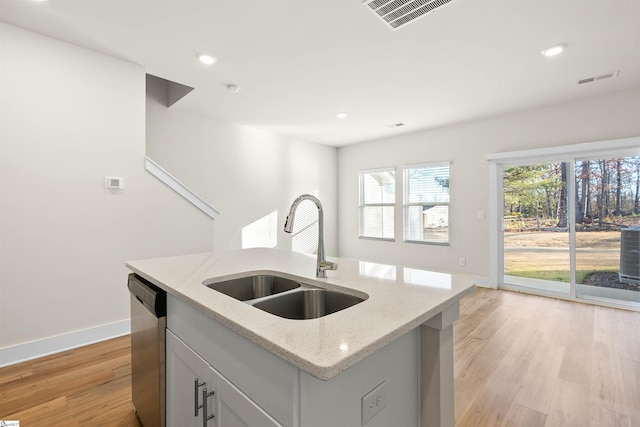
147,77,337,255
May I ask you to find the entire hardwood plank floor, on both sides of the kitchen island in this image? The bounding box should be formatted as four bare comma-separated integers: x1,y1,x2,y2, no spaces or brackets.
0,289,640,427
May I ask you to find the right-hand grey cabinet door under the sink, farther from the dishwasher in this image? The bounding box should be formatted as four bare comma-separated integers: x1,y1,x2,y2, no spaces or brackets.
216,375,282,427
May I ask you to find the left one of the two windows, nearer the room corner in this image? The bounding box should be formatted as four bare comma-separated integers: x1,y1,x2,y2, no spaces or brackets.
360,168,396,240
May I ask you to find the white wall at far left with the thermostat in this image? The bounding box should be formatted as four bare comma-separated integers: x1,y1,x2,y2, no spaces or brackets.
0,23,213,365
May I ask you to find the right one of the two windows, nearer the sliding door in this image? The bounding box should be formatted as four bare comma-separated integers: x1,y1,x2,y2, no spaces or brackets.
404,163,449,244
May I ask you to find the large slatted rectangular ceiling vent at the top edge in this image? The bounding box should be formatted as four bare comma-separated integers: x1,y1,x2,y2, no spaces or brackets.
362,0,452,30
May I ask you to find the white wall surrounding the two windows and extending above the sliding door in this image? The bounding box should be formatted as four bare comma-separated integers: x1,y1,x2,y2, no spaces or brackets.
338,87,640,278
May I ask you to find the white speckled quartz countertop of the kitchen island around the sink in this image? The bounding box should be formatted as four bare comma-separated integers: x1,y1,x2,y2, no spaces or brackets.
127,249,475,380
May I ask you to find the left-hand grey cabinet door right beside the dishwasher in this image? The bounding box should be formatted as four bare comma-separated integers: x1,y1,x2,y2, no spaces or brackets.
166,330,218,427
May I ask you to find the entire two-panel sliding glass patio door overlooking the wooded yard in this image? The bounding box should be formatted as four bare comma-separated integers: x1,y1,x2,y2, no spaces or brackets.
498,150,640,304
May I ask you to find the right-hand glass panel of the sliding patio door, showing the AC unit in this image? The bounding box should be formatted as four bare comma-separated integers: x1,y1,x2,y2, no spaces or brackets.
575,157,640,302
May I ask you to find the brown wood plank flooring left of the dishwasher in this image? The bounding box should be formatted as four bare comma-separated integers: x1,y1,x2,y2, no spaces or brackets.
0,335,141,427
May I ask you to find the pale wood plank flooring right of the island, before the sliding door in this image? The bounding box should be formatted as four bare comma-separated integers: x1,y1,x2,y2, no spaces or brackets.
454,289,640,427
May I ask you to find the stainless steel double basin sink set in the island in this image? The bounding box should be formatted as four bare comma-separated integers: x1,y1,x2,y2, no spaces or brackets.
204,274,366,320
